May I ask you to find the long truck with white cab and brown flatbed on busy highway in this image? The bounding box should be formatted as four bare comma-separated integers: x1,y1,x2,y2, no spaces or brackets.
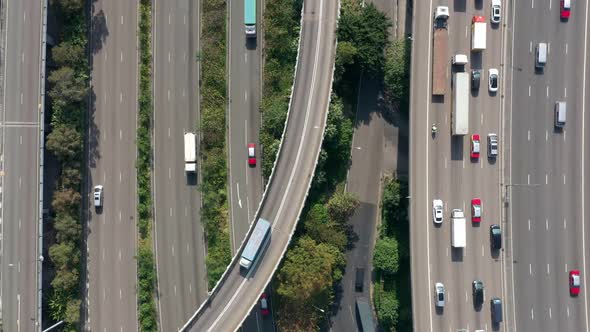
432,6,449,96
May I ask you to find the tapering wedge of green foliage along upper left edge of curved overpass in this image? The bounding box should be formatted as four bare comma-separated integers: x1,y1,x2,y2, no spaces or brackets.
260,0,303,178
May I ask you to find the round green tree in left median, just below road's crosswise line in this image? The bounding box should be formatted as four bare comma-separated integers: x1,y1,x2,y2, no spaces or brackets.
47,126,82,162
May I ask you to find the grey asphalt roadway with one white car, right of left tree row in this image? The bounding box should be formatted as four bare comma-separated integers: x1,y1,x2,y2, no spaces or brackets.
86,0,138,331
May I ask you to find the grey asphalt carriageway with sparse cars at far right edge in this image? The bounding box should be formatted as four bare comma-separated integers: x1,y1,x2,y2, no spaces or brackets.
509,1,589,331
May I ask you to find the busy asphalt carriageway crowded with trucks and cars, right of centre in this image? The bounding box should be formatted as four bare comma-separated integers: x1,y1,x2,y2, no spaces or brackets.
410,1,509,331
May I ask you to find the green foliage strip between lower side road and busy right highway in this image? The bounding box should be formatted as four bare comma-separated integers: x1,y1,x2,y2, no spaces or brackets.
373,179,412,331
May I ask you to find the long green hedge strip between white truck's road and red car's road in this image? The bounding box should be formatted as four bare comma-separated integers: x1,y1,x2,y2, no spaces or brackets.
200,0,231,288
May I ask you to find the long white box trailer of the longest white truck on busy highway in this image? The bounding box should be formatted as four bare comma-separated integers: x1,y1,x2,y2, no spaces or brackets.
451,72,469,135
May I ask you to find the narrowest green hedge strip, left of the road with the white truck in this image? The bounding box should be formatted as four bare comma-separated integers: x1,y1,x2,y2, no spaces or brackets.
137,0,158,332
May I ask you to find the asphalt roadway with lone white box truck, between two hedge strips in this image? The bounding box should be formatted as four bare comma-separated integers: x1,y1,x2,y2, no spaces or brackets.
153,0,207,331
